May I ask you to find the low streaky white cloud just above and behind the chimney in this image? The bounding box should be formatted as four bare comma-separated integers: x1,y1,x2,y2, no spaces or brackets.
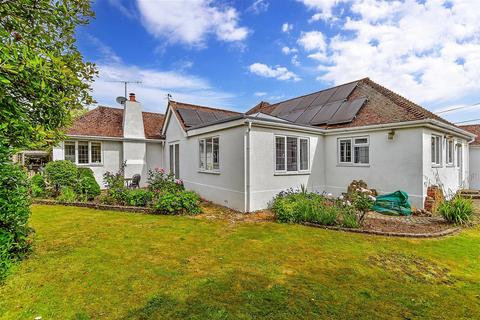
92,63,235,112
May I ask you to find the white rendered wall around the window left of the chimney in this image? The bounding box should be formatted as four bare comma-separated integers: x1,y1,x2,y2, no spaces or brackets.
52,139,123,189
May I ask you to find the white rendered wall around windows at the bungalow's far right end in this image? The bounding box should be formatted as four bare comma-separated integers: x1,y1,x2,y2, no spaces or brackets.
422,129,469,196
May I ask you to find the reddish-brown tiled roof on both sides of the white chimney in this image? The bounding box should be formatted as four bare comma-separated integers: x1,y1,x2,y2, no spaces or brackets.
67,106,165,139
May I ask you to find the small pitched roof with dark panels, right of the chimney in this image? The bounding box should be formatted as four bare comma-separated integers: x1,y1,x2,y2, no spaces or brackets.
169,100,241,129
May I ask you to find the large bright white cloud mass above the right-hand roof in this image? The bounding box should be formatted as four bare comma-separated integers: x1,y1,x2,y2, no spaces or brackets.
299,0,480,104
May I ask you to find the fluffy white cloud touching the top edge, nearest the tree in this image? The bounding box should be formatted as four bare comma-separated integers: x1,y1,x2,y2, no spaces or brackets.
138,0,249,46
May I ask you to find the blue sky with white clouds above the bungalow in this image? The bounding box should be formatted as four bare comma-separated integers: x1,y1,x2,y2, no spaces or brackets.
77,0,480,121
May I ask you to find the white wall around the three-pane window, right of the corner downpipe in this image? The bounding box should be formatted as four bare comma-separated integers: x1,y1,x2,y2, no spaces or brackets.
250,126,325,211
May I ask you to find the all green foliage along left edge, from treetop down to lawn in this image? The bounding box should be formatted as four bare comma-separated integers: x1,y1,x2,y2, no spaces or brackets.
0,0,96,280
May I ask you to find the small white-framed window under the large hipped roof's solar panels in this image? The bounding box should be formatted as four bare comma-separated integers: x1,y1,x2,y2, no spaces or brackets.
337,137,370,165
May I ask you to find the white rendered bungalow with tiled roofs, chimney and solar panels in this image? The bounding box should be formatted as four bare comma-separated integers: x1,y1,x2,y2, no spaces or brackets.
53,78,475,212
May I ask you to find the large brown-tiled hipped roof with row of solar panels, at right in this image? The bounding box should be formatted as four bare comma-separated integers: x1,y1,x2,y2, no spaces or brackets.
247,78,454,128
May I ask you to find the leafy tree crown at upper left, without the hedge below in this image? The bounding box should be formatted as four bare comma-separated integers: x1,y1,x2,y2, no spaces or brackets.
0,0,96,152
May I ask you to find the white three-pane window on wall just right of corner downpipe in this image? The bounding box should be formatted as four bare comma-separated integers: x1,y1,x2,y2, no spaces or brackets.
275,135,310,173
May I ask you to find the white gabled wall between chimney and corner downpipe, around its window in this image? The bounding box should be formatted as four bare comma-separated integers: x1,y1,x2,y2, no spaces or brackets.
164,115,245,211
